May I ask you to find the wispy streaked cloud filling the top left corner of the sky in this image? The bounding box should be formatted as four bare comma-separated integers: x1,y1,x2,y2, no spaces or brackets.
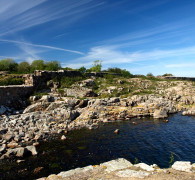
0,0,103,36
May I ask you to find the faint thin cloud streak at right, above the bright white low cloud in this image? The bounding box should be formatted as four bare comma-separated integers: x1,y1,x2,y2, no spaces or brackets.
99,17,195,47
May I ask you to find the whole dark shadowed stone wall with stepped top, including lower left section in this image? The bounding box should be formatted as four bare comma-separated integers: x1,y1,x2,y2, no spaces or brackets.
0,70,82,109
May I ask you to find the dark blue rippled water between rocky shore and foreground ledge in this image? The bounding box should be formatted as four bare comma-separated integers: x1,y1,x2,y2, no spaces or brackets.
0,113,195,179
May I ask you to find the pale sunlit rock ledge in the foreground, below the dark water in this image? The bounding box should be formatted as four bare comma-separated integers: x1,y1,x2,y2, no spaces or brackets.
38,158,195,180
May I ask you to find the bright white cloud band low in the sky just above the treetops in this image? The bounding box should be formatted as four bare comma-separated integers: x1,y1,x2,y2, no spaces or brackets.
65,46,195,68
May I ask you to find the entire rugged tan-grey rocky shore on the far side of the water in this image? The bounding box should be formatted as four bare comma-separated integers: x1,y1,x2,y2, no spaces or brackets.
0,78,195,159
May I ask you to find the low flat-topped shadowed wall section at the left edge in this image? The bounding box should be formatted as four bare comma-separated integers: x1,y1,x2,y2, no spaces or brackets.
0,85,33,108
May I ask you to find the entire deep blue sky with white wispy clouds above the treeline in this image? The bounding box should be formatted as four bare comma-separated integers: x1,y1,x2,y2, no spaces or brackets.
0,0,195,76
